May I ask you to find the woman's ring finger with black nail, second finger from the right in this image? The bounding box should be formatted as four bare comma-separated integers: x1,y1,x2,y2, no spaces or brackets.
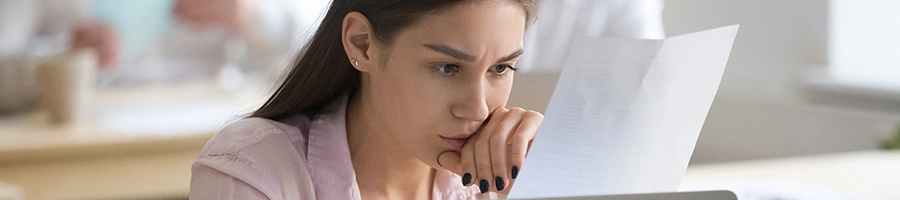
490,107,525,192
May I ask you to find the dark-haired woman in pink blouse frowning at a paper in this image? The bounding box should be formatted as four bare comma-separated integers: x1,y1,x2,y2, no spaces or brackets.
191,0,543,199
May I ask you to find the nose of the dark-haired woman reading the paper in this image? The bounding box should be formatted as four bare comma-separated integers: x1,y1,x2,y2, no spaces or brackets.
450,79,490,122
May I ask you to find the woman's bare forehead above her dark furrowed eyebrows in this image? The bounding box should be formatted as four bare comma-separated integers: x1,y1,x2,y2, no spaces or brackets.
395,1,526,58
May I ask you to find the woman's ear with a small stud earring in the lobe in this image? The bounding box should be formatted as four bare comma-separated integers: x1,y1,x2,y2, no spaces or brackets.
341,12,374,72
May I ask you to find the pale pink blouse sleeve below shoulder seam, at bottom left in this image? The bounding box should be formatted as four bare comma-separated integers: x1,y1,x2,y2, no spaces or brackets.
190,159,269,200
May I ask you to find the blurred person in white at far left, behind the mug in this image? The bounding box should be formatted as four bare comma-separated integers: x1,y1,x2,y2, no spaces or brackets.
0,0,119,113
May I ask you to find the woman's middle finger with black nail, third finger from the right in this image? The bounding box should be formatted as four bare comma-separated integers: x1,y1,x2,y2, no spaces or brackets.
474,108,506,193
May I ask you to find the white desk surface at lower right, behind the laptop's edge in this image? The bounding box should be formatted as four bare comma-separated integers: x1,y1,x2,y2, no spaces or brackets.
682,151,900,199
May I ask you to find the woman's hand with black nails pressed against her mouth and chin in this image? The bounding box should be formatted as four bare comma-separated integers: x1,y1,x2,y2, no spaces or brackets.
438,107,544,194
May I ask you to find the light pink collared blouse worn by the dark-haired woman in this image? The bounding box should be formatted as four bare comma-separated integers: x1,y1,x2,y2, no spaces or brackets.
190,96,478,200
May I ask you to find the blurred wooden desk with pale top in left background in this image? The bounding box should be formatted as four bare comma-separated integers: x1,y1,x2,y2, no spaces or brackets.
0,82,264,164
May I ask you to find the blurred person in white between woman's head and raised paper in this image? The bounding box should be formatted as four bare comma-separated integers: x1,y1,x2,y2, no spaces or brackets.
519,0,666,72
